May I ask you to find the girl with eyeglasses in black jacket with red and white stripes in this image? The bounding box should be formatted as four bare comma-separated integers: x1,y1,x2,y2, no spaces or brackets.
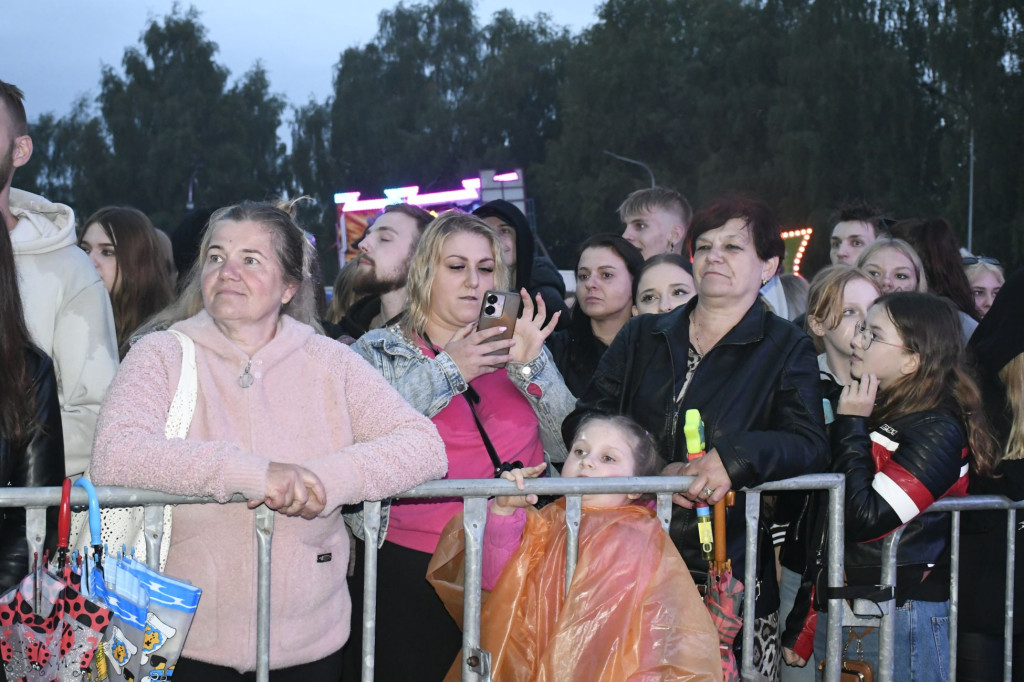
814,292,997,680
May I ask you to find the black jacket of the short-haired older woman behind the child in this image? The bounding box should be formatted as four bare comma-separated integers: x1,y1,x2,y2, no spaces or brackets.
562,299,828,616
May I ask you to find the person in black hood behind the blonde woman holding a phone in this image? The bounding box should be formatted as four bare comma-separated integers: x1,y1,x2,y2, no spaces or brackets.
473,199,569,329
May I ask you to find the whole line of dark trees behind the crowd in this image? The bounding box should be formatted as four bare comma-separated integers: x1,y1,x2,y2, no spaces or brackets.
16,0,1024,275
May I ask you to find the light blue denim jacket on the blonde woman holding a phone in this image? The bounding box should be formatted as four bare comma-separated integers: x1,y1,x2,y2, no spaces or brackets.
346,325,575,542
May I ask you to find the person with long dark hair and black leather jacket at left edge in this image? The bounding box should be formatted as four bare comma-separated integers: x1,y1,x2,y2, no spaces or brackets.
0,218,65,592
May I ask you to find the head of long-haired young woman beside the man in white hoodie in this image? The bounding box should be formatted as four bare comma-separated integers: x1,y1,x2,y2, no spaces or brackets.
78,206,174,359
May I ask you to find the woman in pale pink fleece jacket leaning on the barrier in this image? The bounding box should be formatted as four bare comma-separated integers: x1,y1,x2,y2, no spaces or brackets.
92,202,446,682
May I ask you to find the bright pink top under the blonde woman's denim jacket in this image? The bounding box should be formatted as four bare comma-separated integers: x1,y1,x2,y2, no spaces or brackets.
387,344,544,554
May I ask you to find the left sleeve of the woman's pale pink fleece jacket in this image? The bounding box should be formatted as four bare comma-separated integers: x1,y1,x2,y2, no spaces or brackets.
90,333,269,502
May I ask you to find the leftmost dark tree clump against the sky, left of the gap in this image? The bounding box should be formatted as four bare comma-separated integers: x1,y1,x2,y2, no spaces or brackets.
17,8,287,229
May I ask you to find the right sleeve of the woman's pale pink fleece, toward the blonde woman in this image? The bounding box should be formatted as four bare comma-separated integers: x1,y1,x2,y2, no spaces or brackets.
304,341,447,514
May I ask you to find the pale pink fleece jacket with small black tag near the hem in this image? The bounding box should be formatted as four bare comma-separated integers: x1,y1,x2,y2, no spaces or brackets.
92,311,447,671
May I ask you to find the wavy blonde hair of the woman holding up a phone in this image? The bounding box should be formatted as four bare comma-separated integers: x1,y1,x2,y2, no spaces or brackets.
402,210,511,336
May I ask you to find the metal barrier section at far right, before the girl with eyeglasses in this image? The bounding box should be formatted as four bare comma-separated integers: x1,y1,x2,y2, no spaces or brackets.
878,495,1024,682
